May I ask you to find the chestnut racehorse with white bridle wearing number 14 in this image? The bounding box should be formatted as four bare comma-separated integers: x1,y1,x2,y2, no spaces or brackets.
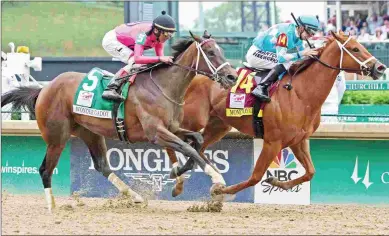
167,32,386,196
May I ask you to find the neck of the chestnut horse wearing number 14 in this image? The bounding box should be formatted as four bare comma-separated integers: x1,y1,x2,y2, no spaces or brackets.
292,43,340,112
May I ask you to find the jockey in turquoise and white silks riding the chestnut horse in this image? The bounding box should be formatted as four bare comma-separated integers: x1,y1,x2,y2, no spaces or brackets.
246,15,320,102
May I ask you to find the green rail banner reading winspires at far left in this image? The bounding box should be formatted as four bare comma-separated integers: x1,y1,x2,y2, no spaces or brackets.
1,136,70,196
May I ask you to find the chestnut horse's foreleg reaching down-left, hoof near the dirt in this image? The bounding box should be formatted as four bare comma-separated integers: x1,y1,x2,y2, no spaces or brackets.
220,142,281,194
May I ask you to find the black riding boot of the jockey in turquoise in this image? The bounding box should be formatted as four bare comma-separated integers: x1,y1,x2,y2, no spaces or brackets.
251,64,286,103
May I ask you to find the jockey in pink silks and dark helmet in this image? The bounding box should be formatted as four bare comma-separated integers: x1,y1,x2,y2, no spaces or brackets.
102,11,176,101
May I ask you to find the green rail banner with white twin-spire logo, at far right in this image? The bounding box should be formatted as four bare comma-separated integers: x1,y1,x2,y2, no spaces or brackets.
310,139,389,204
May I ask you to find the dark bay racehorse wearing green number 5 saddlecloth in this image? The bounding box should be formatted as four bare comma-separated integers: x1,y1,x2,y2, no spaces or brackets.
1,31,237,211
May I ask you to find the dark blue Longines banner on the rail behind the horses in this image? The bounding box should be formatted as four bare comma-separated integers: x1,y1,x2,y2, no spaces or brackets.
71,138,254,202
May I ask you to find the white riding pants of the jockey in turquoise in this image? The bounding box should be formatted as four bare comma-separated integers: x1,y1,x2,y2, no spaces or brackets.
246,45,293,69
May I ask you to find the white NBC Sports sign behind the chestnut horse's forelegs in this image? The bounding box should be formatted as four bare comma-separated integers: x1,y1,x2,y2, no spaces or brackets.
254,139,310,205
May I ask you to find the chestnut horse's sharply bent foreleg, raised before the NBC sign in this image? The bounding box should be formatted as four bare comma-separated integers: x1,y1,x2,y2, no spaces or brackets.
266,139,315,190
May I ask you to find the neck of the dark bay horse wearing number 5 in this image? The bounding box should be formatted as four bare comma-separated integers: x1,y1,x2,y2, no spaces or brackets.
154,46,195,101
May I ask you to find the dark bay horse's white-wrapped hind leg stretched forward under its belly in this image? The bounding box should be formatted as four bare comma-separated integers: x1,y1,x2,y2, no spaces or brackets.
76,127,144,203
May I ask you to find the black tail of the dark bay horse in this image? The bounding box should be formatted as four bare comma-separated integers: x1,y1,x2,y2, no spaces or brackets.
1,86,42,116
